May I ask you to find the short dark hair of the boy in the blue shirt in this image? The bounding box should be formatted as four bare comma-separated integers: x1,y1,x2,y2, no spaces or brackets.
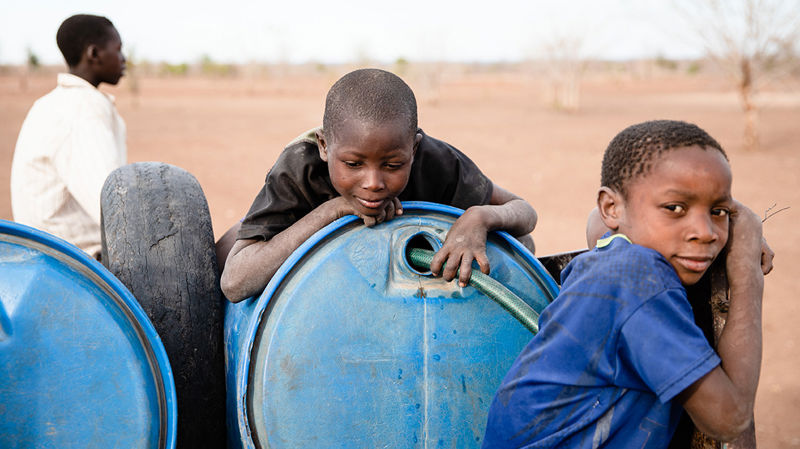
600,120,728,195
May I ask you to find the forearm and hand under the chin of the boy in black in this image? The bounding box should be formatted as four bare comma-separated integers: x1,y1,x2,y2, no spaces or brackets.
220,196,403,302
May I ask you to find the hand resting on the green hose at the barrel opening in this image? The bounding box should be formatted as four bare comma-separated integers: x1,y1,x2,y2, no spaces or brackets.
431,208,489,287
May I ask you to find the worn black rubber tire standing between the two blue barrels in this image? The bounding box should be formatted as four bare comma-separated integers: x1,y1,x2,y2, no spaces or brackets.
101,162,226,448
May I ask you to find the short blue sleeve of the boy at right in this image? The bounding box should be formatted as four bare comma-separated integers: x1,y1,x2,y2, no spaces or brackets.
617,289,720,403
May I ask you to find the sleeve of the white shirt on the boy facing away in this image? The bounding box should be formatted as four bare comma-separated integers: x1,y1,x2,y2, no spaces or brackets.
55,98,124,225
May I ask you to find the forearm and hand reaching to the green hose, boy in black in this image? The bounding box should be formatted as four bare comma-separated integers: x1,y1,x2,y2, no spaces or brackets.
431,183,538,287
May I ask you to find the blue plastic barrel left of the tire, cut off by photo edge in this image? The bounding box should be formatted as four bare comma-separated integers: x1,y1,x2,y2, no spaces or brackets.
0,220,177,449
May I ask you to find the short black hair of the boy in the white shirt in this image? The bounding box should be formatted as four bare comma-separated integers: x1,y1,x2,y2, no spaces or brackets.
56,14,114,67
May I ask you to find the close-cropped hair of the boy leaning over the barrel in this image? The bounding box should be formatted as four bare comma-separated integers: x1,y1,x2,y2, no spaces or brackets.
322,69,417,139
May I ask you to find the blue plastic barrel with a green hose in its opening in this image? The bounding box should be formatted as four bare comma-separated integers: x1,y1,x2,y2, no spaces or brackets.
225,202,558,448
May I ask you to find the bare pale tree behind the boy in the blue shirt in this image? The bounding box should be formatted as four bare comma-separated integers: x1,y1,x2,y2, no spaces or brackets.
675,0,800,149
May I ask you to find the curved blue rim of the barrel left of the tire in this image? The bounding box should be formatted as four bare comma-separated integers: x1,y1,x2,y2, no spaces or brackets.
0,219,177,448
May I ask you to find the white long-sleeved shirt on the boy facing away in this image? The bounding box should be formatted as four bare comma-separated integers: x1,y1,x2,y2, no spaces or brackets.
11,73,127,255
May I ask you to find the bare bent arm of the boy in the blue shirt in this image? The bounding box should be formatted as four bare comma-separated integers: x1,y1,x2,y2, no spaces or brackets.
677,203,764,441
